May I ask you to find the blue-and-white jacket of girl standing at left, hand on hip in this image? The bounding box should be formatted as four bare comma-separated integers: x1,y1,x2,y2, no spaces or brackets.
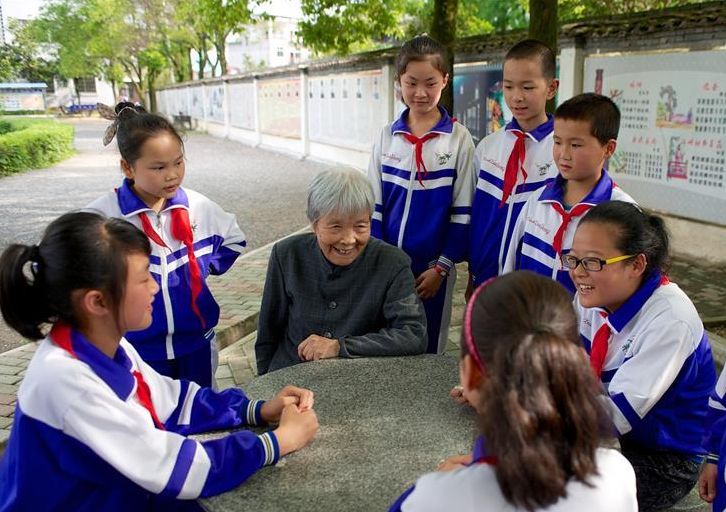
86,180,246,361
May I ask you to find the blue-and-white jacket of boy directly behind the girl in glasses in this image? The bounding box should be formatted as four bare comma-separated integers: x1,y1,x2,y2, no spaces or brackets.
502,170,635,294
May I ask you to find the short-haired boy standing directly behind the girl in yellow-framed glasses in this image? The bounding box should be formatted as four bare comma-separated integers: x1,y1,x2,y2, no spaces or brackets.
503,93,635,293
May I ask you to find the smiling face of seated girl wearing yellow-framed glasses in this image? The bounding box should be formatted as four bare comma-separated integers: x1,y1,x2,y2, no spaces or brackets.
570,222,646,312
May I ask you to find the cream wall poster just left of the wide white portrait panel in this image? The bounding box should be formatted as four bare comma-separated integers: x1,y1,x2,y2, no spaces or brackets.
257,78,301,139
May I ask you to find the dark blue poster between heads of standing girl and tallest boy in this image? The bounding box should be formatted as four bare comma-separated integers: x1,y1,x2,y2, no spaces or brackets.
454,65,512,144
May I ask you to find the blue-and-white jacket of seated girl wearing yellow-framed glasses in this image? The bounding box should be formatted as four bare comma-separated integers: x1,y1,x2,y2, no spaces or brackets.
574,271,716,456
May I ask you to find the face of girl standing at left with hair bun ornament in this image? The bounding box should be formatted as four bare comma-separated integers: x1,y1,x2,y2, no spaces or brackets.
121,131,185,211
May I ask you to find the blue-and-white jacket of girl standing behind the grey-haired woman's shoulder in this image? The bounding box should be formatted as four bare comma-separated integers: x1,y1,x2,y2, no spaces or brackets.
368,108,475,275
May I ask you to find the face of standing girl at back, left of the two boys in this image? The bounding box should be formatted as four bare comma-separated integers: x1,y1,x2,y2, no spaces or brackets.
399,59,449,116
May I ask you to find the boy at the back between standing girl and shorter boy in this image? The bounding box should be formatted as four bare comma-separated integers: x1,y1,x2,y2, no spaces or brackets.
469,39,558,286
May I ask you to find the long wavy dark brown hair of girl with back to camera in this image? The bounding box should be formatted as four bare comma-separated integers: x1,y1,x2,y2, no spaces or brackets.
462,271,610,510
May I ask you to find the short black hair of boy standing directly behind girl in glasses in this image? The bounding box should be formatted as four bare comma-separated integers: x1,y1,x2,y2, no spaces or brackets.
555,92,620,145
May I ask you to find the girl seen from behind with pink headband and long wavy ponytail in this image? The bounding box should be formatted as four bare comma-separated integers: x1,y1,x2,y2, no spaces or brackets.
391,271,637,512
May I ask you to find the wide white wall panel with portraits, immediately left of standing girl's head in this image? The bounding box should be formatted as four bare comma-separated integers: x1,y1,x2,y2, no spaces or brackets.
307,69,388,151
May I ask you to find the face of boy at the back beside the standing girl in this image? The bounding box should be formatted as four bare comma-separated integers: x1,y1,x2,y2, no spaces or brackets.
503,59,557,132
